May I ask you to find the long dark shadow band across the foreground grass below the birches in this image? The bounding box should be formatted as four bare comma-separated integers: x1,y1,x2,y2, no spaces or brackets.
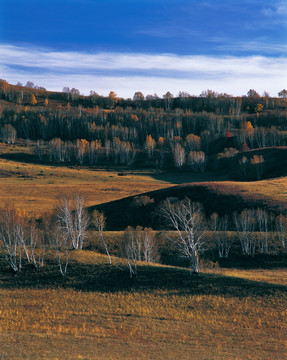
0,262,286,298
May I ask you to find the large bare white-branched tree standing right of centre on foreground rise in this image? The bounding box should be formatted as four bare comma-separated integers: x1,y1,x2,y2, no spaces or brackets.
159,198,206,273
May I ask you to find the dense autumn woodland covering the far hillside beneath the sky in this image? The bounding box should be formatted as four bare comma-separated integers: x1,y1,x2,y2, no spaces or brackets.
0,80,287,179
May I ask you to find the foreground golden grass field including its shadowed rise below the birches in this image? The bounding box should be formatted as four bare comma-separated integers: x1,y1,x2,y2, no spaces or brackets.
0,250,287,360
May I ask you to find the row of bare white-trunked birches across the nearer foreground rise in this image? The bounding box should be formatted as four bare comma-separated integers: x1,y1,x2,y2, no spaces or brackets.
0,194,287,277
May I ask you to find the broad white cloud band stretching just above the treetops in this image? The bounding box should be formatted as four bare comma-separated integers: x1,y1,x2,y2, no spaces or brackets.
0,45,287,97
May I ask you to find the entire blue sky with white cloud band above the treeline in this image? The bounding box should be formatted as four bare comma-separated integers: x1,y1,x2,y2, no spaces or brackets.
0,0,287,98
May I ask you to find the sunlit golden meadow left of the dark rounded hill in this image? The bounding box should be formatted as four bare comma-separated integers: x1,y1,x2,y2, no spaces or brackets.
0,159,172,216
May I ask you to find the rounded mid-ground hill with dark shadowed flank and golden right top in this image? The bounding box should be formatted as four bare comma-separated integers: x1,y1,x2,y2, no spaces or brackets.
90,178,287,230
